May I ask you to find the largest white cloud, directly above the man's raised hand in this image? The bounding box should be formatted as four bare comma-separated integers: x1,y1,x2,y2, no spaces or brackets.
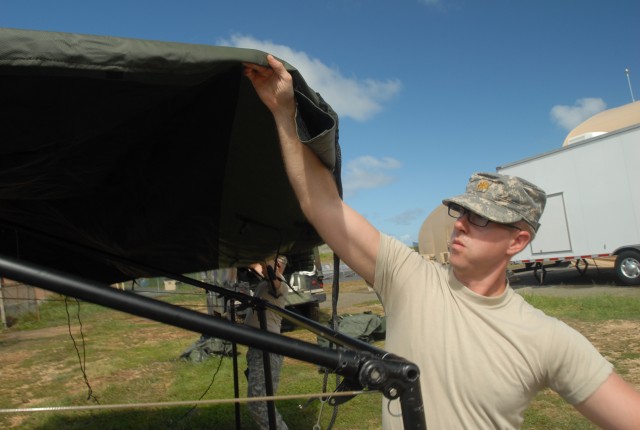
217,35,402,121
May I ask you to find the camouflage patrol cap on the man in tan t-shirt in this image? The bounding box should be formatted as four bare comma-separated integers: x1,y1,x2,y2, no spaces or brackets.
442,173,547,231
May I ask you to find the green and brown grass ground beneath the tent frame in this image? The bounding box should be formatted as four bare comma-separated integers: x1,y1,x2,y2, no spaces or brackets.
0,290,381,430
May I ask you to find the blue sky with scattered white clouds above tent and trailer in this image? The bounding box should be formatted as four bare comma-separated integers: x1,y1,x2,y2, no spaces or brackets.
0,0,640,243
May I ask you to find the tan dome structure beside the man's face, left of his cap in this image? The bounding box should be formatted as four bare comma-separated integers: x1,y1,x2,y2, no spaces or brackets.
418,205,455,263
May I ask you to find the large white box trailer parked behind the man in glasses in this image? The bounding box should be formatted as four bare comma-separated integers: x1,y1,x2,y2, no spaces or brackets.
496,123,640,285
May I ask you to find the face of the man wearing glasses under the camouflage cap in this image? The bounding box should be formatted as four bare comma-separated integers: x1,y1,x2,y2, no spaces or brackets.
449,209,521,279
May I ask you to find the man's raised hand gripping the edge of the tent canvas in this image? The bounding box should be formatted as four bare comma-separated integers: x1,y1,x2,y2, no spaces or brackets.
244,54,296,119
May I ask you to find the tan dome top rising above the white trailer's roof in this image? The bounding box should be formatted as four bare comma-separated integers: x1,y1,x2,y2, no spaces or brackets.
562,101,640,146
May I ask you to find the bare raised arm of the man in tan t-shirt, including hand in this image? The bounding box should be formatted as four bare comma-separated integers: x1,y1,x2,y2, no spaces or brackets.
244,55,380,283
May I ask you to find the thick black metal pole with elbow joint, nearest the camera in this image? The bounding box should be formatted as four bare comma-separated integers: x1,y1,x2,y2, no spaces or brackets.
0,255,426,430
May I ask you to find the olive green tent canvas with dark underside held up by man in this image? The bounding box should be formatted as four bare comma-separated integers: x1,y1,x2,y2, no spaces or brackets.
0,29,340,283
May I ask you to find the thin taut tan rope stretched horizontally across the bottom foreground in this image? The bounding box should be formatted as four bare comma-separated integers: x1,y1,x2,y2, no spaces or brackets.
0,391,378,414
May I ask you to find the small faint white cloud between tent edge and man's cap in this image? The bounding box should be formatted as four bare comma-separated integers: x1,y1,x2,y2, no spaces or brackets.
342,155,402,197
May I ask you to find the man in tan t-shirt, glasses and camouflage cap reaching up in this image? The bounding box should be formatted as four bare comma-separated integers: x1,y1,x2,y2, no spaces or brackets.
244,55,640,429
